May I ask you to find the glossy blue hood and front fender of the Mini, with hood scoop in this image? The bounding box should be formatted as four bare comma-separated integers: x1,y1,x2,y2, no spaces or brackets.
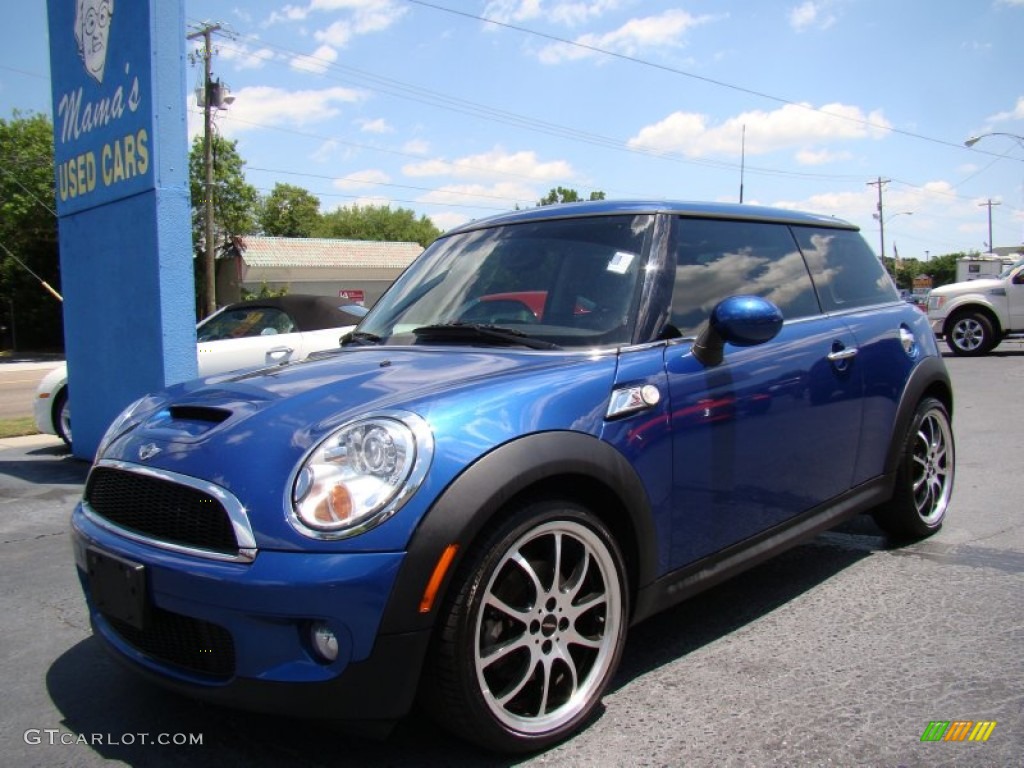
99,346,617,549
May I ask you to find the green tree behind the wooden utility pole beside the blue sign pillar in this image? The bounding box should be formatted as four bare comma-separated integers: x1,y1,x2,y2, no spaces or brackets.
188,134,259,306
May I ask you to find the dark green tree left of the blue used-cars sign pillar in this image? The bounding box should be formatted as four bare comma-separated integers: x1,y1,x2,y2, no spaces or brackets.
0,111,63,349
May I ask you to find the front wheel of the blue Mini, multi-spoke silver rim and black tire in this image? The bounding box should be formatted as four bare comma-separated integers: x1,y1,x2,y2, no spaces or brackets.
424,500,629,752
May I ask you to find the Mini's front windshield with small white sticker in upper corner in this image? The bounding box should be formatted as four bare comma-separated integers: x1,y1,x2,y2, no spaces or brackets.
354,215,653,348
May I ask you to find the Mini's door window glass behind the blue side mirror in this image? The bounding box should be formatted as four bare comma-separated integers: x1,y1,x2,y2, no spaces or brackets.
671,218,820,335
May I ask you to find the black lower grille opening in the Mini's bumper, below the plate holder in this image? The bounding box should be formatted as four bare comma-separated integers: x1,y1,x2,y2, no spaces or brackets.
103,606,234,680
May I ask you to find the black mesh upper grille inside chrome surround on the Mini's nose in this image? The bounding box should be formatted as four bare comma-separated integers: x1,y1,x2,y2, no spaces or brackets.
85,467,239,555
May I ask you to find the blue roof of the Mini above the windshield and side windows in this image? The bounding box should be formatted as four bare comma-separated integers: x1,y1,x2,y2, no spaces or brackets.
445,200,859,236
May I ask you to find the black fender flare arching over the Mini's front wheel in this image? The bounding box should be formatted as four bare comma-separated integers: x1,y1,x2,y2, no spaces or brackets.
380,431,657,635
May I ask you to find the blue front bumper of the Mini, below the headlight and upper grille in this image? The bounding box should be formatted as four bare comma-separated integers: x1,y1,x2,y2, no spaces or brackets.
72,506,430,720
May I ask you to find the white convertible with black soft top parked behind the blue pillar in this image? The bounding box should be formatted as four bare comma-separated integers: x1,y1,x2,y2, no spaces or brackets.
33,295,367,445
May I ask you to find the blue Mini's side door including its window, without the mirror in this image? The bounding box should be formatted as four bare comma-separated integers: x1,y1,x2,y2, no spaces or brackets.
666,219,863,567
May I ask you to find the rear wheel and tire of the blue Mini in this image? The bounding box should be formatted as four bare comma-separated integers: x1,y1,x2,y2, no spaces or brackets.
874,397,956,539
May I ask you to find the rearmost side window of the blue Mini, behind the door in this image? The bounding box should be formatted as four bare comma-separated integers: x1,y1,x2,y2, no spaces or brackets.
793,226,898,312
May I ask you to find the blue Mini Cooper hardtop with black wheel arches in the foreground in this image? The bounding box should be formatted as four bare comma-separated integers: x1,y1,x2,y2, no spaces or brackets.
73,202,954,752
